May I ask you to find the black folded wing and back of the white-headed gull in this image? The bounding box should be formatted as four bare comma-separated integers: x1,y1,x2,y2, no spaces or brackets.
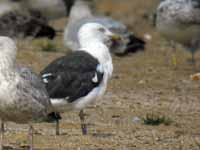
41,51,103,102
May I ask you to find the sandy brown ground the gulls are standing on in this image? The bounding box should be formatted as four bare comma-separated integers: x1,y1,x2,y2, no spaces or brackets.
1,0,200,150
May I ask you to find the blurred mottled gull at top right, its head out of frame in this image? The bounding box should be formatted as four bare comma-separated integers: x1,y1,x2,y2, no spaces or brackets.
156,0,200,66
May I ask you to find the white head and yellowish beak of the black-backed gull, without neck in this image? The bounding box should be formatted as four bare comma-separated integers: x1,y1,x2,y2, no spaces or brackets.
78,23,120,48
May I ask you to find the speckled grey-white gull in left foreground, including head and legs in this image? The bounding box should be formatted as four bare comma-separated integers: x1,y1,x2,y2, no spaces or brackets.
0,36,57,149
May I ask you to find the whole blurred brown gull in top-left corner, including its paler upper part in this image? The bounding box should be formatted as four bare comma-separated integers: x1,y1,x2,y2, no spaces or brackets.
0,0,56,39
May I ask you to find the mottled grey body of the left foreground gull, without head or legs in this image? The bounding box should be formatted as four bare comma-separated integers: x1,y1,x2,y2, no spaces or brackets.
0,68,53,123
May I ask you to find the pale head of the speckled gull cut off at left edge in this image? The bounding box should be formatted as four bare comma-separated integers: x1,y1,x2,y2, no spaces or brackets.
0,36,17,66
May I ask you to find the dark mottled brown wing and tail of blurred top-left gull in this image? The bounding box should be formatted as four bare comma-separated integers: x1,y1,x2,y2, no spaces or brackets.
0,11,56,39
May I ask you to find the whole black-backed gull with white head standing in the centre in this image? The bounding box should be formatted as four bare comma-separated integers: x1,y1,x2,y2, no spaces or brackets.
41,23,120,134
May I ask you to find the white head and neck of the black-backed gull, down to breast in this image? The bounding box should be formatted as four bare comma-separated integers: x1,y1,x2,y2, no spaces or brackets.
78,23,118,77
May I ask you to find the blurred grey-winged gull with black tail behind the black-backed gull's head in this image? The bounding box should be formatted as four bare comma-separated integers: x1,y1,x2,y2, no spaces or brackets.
64,0,145,55
